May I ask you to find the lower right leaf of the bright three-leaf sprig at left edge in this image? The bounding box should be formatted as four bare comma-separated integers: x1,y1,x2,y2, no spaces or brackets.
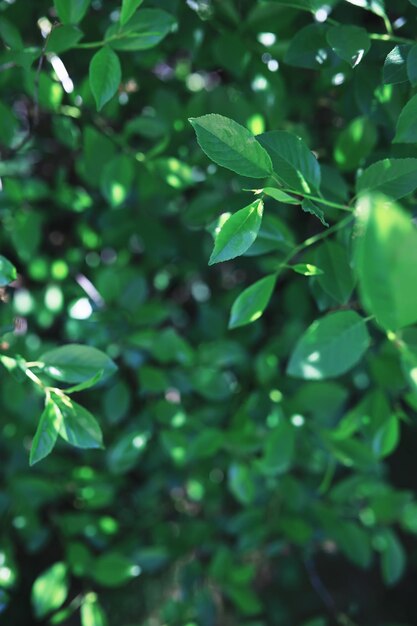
54,396,103,448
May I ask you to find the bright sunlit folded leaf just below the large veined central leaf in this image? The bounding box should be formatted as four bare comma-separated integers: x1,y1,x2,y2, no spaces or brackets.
209,200,264,265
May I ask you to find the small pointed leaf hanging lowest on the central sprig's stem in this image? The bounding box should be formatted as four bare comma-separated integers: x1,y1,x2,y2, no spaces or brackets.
229,274,277,328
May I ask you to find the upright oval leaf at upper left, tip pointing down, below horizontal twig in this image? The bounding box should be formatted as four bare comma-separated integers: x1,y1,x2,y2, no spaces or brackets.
89,46,122,111
